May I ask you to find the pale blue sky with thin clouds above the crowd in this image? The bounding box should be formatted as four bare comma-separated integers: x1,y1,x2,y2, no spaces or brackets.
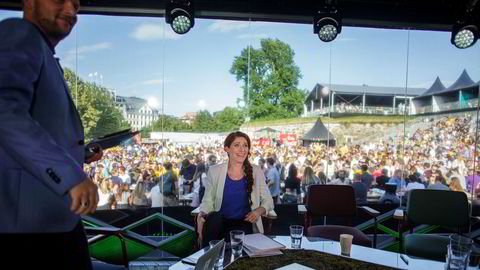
0,10,480,116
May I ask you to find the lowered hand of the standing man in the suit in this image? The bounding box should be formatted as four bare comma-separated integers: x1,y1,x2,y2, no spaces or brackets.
69,177,98,215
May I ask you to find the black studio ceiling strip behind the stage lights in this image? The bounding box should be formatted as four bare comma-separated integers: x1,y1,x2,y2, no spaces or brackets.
0,0,480,31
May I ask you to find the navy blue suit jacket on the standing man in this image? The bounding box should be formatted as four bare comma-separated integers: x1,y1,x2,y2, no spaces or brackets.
0,19,86,233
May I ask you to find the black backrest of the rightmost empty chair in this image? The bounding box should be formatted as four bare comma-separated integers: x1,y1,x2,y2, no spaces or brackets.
407,189,470,227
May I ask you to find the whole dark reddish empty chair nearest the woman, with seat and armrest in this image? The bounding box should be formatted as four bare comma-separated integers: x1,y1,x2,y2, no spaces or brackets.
304,185,379,247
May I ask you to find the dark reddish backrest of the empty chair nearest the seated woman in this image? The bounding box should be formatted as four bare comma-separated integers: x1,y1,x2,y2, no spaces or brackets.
307,185,357,217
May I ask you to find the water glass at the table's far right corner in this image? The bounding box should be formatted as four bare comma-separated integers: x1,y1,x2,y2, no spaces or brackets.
446,234,472,270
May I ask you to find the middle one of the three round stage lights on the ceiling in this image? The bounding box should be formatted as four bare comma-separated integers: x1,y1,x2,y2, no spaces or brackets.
313,8,342,42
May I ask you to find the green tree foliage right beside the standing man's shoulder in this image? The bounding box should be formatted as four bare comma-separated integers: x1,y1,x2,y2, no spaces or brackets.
64,69,129,140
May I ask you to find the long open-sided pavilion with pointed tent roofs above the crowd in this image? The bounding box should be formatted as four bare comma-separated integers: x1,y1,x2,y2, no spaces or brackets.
303,70,480,117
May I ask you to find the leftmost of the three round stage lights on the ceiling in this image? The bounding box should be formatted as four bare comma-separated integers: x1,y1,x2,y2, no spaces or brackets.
165,0,195,35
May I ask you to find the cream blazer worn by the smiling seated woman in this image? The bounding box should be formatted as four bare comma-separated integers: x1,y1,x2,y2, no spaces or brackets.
200,163,273,233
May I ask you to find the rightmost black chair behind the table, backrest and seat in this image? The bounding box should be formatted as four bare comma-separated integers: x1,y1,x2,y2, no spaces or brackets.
404,189,470,261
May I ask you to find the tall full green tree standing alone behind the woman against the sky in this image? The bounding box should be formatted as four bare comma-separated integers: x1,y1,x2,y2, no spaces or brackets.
230,39,306,119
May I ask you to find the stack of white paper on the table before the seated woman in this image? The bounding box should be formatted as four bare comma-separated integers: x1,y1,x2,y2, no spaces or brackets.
243,233,285,257
